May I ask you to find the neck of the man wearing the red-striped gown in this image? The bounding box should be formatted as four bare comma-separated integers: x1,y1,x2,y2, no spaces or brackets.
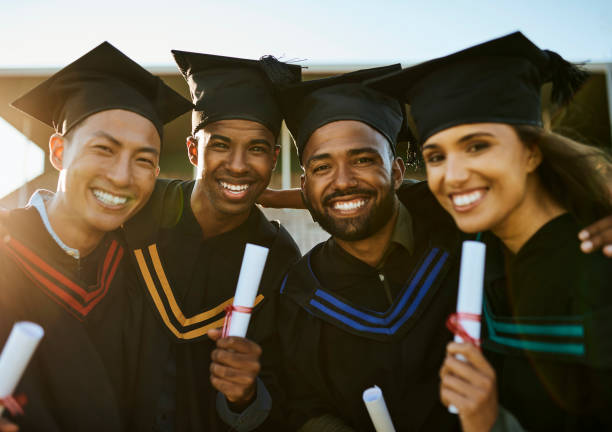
45,194,105,258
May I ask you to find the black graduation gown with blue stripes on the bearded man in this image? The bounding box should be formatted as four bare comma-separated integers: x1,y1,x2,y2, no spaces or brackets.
277,183,459,431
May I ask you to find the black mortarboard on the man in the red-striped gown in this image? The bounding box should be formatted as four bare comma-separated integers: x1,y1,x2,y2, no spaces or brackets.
11,42,193,137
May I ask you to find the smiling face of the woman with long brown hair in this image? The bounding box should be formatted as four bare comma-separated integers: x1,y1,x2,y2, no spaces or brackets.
423,123,541,233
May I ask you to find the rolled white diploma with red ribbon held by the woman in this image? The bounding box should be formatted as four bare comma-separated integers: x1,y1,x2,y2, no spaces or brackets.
448,241,487,414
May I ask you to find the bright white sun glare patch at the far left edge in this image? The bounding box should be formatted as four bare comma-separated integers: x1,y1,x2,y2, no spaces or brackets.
0,118,45,197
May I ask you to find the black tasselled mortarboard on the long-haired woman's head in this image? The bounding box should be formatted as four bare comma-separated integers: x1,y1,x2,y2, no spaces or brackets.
367,32,586,142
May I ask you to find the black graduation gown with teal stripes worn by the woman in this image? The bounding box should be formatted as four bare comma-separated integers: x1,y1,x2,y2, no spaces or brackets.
483,214,612,431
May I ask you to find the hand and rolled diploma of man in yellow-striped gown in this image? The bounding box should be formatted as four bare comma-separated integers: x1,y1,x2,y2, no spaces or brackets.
208,243,268,407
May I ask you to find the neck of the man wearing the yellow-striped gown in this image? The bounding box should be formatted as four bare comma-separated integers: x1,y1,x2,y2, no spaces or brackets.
190,180,251,239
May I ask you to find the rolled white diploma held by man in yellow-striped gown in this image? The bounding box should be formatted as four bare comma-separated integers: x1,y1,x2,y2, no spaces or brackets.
228,243,269,337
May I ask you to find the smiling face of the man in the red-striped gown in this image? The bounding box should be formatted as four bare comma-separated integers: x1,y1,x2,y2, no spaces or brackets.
50,109,161,233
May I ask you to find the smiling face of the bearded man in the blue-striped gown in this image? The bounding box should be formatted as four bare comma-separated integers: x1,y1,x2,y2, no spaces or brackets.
302,120,404,241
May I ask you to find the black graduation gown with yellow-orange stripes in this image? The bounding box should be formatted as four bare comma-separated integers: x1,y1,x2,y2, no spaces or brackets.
124,180,300,431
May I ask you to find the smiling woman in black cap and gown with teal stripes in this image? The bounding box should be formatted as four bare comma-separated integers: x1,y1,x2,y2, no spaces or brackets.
373,33,612,431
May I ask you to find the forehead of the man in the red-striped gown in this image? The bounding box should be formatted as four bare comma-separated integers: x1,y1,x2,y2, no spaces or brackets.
75,109,161,150
